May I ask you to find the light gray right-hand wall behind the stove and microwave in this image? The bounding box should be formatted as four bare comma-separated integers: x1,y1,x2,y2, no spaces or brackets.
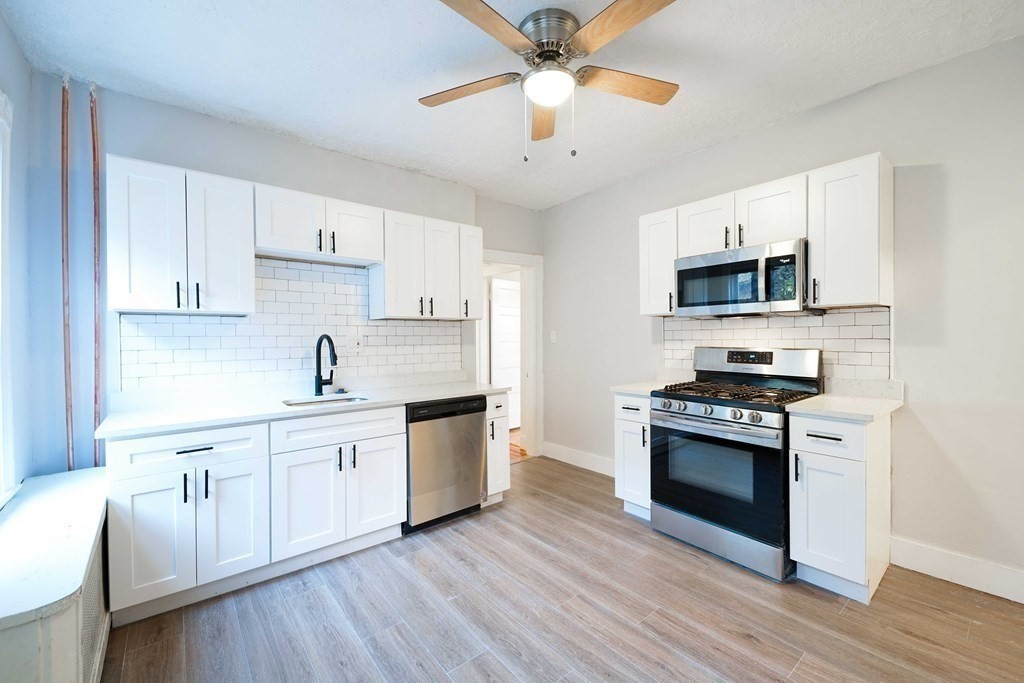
544,39,1024,569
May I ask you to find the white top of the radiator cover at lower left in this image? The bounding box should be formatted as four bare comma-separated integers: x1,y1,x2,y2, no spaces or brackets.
0,467,106,629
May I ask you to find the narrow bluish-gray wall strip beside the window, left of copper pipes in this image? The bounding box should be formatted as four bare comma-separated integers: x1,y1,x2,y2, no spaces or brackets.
0,9,31,481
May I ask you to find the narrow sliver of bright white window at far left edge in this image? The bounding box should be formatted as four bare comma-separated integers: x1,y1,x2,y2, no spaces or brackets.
0,87,16,506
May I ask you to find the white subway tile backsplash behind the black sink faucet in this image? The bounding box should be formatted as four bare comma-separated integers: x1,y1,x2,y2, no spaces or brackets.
119,258,464,391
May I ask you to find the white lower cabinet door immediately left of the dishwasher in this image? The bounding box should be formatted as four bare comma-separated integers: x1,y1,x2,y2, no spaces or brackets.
344,434,407,539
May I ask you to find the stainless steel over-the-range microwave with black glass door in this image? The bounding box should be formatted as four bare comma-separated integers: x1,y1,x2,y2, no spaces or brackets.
676,240,807,317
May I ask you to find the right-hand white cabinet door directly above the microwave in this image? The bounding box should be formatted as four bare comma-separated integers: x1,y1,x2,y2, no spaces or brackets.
729,173,807,248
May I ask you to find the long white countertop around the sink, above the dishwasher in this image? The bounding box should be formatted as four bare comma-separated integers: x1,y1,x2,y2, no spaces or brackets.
96,382,510,439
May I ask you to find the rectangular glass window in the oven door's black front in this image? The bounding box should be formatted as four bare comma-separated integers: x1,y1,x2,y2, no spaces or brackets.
669,439,754,503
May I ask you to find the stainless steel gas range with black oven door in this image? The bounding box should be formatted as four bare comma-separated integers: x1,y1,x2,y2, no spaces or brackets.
650,348,822,581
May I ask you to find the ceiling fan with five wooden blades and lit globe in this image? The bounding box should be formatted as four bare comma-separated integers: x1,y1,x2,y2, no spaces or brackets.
420,0,679,150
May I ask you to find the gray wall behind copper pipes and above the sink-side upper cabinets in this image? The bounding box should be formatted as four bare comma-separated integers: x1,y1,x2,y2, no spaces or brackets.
24,73,483,473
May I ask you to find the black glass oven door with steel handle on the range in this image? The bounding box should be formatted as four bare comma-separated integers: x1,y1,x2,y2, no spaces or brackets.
650,411,786,548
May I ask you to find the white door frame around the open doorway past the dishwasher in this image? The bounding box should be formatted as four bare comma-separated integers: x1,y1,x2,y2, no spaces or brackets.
462,249,544,455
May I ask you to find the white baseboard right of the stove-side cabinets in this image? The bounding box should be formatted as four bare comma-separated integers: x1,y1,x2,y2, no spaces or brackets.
891,536,1024,602
